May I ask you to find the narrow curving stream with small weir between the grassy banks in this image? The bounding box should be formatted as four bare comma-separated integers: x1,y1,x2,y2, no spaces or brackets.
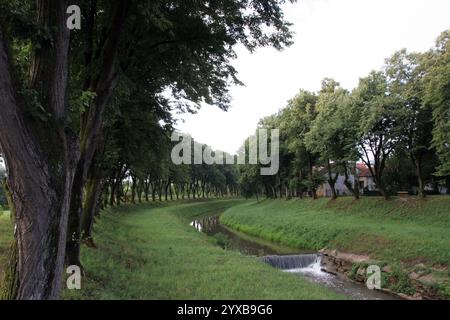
190,215,399,300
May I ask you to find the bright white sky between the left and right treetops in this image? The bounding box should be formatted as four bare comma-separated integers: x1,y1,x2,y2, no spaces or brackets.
174,0,450,153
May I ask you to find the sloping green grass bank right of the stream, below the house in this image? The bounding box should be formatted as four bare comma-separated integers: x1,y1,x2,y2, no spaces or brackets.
221,196,450,297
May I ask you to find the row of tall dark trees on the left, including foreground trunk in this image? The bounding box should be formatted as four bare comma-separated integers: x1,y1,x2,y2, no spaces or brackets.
0,0,292,299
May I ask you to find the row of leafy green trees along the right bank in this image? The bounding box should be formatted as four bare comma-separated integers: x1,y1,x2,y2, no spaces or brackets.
239,31,450,198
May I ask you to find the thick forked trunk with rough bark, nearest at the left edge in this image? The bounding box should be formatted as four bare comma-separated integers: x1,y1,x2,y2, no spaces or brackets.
0,0,78,299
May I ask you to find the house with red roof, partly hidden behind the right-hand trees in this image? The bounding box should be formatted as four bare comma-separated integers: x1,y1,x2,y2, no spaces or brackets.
317,163,376,197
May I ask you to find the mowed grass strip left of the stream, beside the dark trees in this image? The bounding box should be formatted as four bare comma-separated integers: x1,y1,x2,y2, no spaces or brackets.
64,200,342,299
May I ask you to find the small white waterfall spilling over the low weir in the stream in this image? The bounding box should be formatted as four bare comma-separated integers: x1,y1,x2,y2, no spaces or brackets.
262,254,320,270
